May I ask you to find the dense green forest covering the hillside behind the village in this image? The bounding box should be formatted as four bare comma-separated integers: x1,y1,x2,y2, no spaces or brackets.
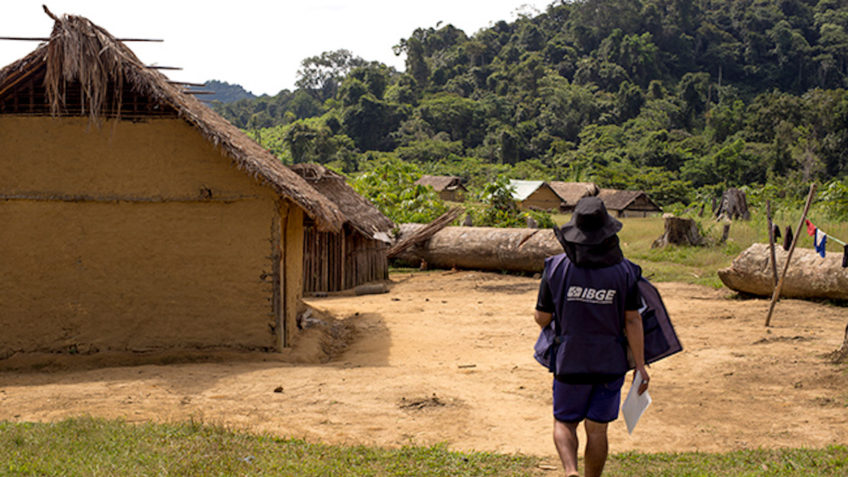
214,0,848,219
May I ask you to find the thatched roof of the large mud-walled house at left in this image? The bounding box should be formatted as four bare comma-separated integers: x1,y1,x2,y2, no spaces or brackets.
0,7,344,231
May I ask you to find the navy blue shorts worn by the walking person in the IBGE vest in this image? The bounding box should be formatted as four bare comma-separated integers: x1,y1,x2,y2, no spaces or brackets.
554,376,624,422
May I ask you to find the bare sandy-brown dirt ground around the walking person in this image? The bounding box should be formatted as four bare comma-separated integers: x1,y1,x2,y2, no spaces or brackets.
0,271,848,462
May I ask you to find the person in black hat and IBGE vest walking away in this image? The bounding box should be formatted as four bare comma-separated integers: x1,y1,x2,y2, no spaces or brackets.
535,197,650,477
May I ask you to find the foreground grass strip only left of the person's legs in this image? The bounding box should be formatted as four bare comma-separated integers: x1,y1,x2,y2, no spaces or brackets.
0,418,539,476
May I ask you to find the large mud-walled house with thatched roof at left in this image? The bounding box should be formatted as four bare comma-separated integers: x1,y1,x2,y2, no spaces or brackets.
0,12,344,358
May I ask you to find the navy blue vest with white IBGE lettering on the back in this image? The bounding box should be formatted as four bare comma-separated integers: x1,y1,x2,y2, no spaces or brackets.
545,254,639,375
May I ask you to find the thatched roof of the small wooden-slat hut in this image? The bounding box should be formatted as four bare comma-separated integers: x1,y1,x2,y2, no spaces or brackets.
291,164,395,241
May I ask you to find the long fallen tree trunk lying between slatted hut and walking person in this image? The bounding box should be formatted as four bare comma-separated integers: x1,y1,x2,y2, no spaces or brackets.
390,224,562,272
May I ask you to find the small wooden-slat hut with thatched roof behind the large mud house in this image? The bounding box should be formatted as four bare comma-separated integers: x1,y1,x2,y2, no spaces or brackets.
291,164,394,293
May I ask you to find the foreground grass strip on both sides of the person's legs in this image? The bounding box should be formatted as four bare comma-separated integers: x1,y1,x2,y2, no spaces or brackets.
0,418,848,477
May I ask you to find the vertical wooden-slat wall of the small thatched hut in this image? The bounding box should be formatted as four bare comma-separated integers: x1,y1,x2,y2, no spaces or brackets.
303,225,389,293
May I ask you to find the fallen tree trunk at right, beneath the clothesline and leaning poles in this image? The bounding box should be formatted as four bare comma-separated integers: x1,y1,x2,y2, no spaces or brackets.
718,243,848,300
